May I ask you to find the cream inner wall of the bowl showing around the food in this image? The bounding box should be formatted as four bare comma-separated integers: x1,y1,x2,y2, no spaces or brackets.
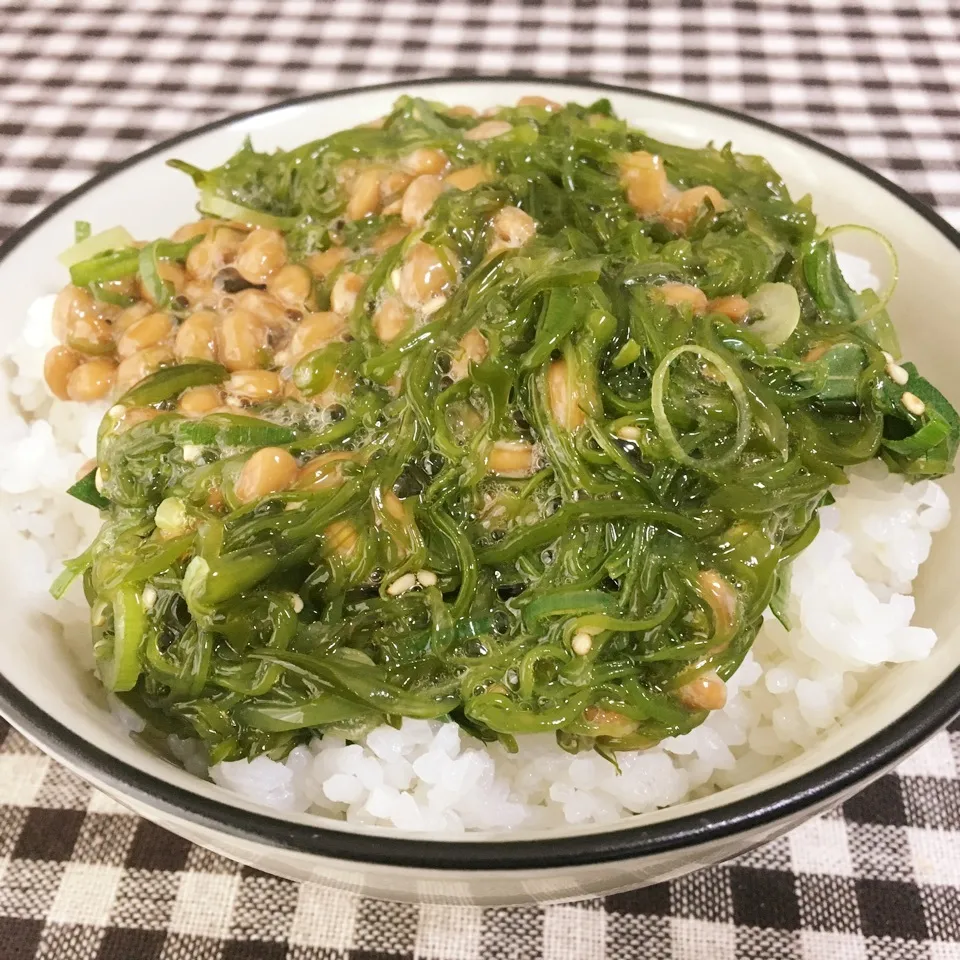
0,81,960,840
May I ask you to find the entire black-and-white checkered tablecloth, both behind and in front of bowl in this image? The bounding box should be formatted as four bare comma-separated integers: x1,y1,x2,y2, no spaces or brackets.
0,0,960,960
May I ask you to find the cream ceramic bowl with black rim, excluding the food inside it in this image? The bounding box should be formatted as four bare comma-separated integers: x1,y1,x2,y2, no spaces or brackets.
0,80,960,904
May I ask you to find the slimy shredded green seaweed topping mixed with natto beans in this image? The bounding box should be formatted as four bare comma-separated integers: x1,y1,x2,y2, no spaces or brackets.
56,97,960,760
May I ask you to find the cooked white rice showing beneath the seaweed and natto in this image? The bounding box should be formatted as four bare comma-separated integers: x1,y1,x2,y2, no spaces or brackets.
0,298,950,833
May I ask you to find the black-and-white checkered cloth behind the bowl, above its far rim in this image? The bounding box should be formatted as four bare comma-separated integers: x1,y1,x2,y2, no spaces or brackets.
0,0,960,234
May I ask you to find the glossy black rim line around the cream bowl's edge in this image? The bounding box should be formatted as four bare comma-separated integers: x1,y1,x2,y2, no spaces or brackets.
0,74,960,874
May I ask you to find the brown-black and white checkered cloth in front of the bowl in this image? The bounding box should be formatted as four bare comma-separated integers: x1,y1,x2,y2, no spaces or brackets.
0,731,960,960
